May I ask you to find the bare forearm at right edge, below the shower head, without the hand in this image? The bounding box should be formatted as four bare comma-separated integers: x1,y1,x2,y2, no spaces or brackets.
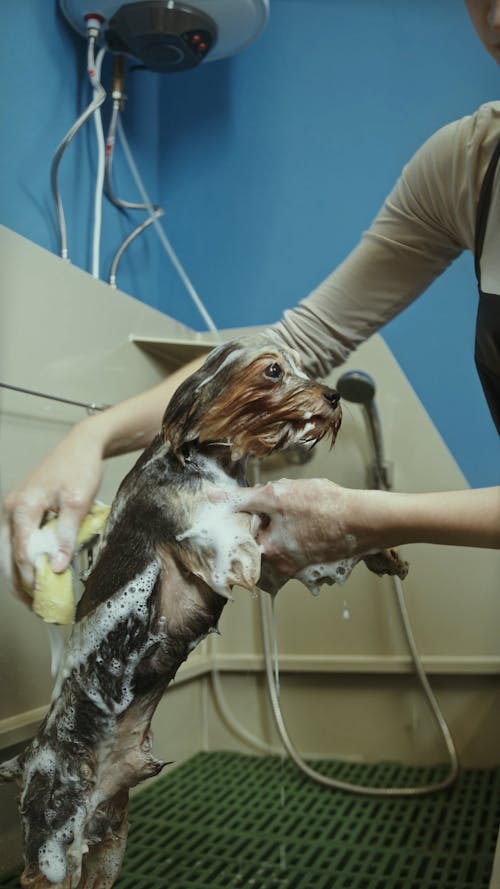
348,487,500,552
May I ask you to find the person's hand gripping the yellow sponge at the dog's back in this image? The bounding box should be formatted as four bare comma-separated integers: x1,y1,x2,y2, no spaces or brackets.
2,421,103,603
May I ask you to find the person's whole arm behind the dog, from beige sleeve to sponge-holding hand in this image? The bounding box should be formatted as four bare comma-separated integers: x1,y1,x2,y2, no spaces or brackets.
4,112,498,583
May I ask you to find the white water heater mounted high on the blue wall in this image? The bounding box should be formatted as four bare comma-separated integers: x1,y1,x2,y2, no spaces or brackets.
60,0,269,72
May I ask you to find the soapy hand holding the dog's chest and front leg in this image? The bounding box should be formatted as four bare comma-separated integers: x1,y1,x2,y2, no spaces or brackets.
235,478,359,583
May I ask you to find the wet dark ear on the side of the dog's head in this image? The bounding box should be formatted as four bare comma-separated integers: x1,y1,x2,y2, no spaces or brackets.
162,340,241,459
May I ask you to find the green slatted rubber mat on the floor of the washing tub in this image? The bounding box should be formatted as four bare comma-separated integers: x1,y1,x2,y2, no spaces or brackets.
0,753,500,889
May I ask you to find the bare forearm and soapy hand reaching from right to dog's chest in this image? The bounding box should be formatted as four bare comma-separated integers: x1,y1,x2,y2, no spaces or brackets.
235,479,500,577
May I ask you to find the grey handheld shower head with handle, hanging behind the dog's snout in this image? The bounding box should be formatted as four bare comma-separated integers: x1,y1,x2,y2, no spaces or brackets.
336,370,391,490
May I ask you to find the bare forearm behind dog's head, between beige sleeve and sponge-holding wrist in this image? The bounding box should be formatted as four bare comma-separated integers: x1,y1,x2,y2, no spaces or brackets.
75,356,204,458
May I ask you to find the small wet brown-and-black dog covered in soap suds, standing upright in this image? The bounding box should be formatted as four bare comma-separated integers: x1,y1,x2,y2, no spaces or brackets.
0,341,341,889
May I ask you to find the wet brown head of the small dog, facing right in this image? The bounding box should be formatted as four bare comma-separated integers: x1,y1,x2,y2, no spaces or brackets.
163,340,342,461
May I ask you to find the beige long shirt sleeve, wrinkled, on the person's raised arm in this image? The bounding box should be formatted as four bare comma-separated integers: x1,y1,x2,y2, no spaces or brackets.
272,102,500,376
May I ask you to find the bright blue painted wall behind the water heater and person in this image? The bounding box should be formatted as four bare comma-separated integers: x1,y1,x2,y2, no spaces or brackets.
0,0,500,485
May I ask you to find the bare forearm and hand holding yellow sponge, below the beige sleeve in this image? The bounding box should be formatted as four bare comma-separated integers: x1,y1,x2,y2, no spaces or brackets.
3,358,204,587
